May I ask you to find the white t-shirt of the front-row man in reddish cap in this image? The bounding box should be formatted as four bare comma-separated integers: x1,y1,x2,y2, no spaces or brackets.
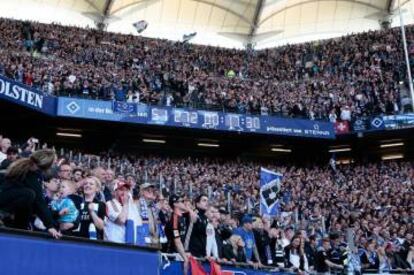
104,199,125,243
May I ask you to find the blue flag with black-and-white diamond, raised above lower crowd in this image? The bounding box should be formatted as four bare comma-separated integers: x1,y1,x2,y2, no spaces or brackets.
260,167,283,216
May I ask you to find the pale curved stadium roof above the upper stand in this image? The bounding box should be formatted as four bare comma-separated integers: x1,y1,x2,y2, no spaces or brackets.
0,0,414,48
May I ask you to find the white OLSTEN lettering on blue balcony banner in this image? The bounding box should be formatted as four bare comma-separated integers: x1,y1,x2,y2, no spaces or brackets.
0,79,43,109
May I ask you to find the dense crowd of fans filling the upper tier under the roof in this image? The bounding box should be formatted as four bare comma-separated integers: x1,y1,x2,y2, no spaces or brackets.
0,19,414,121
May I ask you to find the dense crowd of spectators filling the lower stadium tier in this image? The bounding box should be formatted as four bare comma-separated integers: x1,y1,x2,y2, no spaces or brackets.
0,136,414,274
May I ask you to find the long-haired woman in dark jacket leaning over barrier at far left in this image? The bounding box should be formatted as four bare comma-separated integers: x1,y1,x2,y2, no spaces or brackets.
0,149,61,238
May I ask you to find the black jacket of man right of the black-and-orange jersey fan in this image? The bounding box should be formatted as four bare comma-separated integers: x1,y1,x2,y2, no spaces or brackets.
189,209,208,257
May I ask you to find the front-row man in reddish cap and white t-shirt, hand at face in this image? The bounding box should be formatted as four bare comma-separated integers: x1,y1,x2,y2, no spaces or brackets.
104,181,131,243
